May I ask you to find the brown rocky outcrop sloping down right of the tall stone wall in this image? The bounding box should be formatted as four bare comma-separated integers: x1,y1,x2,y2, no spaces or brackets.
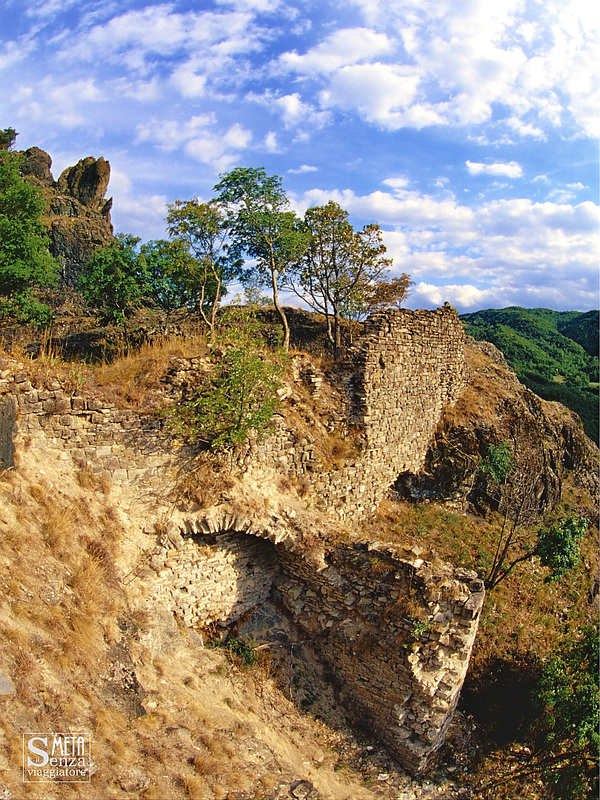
395,340,598,513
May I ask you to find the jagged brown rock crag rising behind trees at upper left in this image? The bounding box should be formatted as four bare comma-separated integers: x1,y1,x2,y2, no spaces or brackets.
21,147,113,286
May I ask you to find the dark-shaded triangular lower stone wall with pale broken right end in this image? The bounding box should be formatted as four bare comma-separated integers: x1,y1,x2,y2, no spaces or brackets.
276,543,484,773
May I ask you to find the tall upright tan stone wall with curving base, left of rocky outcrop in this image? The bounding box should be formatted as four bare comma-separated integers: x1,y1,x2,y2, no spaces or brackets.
243,304,466,520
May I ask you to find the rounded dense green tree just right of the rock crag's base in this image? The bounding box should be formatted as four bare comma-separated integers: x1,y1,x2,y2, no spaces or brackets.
79,233,147,351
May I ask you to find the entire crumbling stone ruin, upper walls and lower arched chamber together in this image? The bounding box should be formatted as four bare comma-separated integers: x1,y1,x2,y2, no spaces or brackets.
0,306,484,773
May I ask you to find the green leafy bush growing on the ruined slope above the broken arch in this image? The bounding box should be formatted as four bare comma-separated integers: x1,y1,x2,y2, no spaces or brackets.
172,343,283,450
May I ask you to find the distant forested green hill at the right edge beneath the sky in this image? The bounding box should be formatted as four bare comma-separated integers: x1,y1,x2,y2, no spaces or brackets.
461,307,599,442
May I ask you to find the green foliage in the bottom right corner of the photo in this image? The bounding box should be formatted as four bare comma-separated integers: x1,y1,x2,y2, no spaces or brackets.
534,623,600,800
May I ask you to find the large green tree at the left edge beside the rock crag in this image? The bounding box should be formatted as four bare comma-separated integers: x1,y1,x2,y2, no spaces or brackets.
0,147,58,323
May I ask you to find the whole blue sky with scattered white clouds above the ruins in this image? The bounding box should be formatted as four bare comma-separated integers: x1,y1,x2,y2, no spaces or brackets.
0,0,600,311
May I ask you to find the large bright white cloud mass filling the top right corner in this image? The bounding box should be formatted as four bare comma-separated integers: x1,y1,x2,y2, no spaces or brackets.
308,0,600,139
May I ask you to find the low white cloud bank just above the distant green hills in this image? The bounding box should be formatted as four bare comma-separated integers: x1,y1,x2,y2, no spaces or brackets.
294,184,600,310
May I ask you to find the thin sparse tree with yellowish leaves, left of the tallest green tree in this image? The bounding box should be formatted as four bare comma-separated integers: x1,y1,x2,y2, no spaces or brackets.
167,200,235,331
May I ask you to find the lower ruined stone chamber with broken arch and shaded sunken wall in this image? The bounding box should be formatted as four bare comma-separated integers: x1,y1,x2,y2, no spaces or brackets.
142,506,484,773
